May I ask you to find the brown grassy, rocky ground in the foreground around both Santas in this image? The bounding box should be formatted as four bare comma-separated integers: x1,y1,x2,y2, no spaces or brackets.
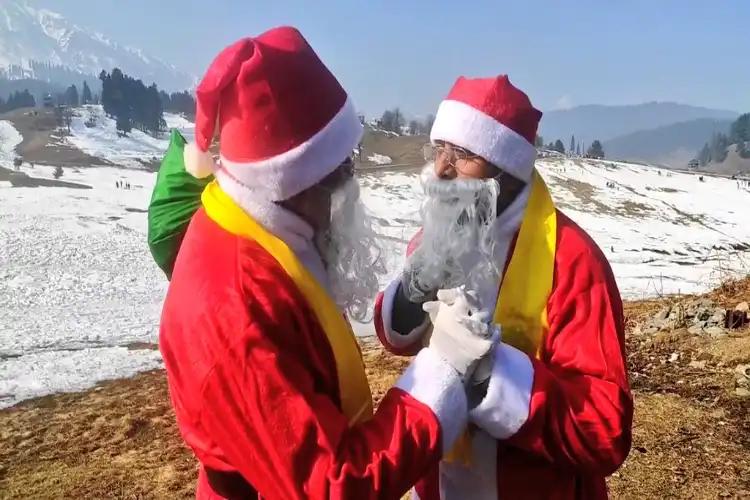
0,279,750,500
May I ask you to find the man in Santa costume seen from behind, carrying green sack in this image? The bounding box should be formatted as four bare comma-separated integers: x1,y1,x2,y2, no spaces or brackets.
160,27,497,500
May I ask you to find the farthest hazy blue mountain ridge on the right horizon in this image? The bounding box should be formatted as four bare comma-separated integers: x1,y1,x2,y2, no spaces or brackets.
539,102,739,147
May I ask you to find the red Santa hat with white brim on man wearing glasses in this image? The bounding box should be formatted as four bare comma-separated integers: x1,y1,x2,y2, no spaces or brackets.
430,75,542,180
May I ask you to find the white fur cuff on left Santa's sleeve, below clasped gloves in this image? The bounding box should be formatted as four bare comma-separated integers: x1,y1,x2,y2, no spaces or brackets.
396,348,468,454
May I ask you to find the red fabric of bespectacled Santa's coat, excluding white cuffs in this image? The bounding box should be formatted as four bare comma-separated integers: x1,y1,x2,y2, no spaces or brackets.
376,210,633,500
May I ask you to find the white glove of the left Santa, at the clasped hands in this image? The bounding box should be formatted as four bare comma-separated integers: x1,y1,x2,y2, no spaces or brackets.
422,289,497,382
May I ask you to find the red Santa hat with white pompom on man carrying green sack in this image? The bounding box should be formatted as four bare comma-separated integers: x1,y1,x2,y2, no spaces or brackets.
185,27,363,201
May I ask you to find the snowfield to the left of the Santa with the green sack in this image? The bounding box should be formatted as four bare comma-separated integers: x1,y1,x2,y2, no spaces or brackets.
0,160,166,407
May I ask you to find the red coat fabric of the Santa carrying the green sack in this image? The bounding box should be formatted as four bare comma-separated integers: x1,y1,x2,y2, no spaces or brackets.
160,209,442,499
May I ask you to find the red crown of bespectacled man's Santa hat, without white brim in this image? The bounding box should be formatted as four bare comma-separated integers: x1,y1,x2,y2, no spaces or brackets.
445,75,542,144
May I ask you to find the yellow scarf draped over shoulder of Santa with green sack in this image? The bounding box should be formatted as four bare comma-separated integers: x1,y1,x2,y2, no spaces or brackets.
201,181,373,425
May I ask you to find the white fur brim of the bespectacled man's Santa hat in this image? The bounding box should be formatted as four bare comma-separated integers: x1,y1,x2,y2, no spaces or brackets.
430,100,536,181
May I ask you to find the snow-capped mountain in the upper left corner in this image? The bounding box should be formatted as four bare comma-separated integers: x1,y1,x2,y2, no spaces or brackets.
0,0,196,91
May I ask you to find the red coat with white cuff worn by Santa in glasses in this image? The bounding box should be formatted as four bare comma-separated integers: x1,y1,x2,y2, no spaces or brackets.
375,210,633,500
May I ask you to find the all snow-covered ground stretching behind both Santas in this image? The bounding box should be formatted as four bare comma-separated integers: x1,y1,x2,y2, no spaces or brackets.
0,117,750,407
